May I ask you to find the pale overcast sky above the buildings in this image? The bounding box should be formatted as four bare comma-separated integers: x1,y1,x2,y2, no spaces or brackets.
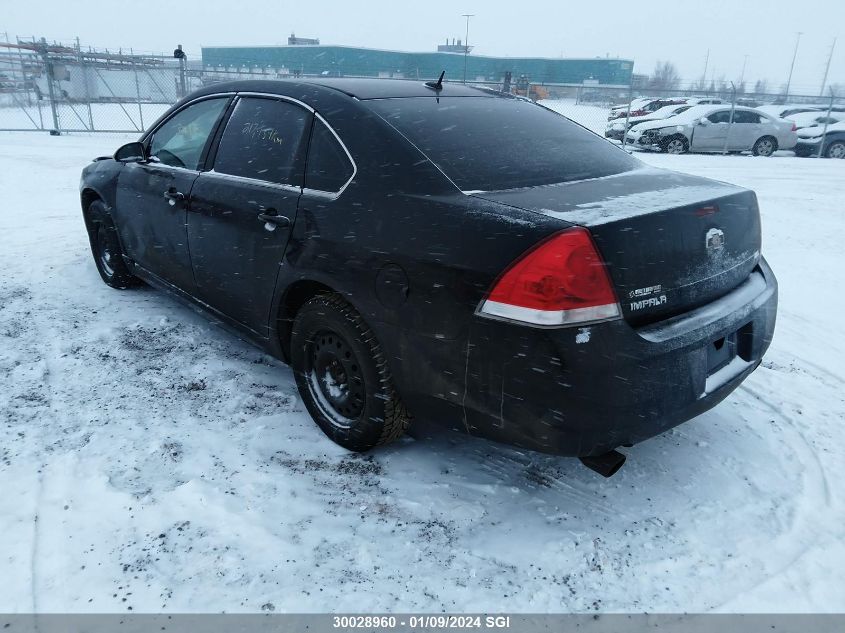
0,0,845,94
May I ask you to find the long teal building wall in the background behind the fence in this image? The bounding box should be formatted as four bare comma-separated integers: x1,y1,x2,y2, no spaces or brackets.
202,46,633,85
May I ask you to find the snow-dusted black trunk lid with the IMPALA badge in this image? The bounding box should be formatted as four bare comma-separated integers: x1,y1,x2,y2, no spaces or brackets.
473,168,760,325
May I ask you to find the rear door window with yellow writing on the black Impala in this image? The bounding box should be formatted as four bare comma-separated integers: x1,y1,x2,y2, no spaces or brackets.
214,97,311,187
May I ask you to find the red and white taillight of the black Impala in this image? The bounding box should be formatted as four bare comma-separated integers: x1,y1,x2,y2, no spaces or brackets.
478,227,620,326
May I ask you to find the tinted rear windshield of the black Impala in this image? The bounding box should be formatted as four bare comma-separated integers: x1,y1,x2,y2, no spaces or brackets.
368,97,637,191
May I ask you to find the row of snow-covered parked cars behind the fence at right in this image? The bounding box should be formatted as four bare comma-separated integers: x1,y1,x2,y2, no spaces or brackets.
605,97,845,158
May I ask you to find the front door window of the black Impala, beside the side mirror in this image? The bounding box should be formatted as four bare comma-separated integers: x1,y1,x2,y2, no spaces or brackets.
150,98,229,169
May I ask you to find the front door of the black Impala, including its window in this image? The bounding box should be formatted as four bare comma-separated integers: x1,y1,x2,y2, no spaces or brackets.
113,97,230,293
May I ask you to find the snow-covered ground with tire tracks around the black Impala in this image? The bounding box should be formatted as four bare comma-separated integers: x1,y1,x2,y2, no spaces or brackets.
0,133,845,612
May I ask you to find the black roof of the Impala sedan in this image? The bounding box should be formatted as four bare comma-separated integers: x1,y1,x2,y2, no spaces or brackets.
186,77,488,100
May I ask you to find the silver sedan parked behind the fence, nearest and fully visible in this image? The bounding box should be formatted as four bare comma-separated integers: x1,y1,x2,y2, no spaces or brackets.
626,105,798,156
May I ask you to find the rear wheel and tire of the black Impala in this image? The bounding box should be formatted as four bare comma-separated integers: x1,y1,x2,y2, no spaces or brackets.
291,294,410,451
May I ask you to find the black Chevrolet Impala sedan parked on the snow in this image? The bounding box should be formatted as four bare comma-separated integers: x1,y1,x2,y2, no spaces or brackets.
81,79,777,475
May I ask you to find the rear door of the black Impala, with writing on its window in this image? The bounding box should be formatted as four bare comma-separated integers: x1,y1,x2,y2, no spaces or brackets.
187,96,313,336
